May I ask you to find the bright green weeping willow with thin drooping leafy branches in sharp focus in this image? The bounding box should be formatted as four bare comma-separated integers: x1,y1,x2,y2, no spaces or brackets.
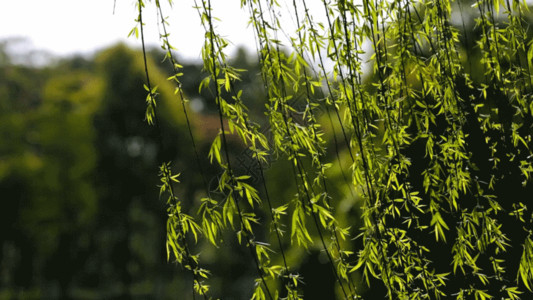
128,0,533,299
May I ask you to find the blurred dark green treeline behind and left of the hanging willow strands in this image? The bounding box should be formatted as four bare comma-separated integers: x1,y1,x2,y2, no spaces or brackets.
0,41,355,299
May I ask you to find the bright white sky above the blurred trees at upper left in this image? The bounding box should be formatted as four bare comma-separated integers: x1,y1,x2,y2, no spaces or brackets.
0,0,255,59
